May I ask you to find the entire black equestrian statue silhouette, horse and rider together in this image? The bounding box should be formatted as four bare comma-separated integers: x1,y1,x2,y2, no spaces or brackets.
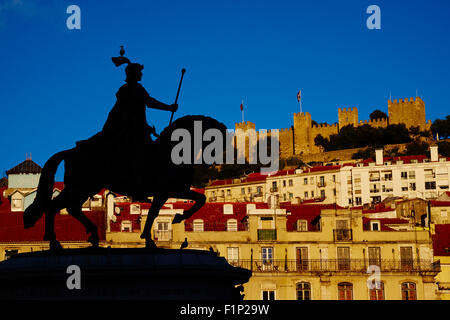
23,47,227,250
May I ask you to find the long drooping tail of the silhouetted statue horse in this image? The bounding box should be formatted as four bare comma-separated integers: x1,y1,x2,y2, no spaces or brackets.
23,150,70,229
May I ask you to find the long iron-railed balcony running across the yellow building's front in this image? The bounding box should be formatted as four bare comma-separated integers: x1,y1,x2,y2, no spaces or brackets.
229,259,441,274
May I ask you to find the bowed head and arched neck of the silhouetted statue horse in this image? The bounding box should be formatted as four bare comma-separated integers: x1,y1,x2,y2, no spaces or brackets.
156,115,227,170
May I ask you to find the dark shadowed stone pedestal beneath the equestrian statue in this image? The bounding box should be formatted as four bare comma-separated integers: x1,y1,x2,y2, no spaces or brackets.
0,248,251,300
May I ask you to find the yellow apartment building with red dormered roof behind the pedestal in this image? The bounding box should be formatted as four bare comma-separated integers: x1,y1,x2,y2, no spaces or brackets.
106,202,440,300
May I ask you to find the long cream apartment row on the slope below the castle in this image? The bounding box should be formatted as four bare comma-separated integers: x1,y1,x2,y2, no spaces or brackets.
206,146,450,207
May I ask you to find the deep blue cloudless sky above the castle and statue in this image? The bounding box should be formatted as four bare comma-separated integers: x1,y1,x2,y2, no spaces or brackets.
0,0,450,175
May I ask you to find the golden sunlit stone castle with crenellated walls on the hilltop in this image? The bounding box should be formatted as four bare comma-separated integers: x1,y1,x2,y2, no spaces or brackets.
235,97,431,158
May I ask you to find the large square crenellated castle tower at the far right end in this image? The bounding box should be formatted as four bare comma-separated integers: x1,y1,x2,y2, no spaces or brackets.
388,97,429,130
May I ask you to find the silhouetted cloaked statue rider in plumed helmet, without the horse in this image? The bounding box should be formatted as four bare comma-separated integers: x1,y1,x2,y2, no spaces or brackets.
77,51,178,192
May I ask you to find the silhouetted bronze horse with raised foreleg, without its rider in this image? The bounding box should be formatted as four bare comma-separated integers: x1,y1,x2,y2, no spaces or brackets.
23,115,227,250
